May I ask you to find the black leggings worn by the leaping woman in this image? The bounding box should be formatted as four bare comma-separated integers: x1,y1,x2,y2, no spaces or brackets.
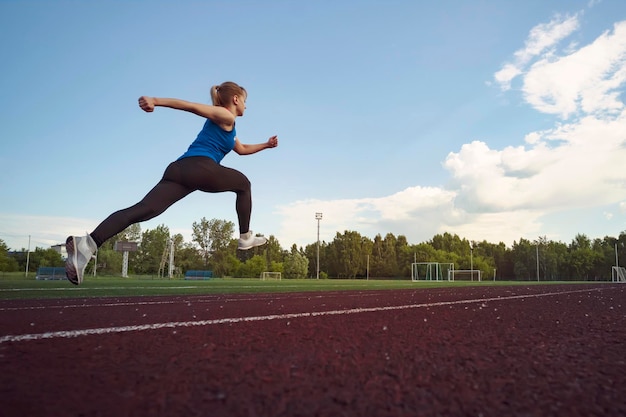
91,156,252,247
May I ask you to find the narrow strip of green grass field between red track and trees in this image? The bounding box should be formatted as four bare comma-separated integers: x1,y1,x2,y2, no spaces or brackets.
0,274,600,300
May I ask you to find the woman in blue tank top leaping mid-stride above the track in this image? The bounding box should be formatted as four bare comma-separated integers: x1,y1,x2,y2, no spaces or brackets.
65,81,278,285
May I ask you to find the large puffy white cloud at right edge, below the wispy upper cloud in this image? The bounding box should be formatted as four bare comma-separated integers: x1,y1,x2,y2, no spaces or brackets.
444,112,626,213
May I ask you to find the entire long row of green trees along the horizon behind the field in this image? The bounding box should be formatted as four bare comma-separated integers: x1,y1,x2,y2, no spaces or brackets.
0,218,626,281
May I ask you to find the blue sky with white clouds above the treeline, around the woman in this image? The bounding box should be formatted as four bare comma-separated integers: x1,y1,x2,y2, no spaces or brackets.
0,0,626,249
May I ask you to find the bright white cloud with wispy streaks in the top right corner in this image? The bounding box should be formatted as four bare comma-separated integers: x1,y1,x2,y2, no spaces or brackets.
494,15,626,119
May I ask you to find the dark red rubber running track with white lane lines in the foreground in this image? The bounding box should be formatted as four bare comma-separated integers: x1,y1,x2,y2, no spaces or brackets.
0,284,626,417
